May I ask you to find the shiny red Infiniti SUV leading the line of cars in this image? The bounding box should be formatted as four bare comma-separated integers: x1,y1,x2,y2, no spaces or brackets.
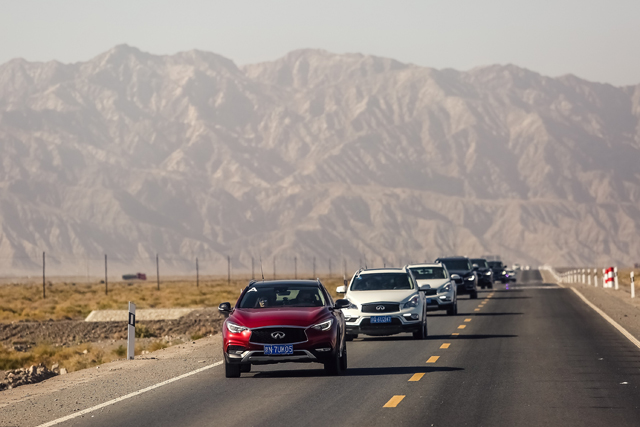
218,280,349,378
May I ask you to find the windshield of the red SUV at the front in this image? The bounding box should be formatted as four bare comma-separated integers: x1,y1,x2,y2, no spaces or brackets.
239,285,325,308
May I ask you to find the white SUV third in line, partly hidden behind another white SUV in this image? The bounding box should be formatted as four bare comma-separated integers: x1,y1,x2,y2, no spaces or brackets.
407,264,460,316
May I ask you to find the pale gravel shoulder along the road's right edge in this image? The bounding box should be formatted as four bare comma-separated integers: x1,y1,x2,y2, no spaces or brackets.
540,270,640,339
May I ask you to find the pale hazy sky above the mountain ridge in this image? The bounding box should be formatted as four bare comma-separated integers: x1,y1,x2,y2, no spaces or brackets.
0,0,640,85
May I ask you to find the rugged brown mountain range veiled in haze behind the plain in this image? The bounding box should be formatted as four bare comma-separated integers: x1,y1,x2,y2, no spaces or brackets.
0,45,640,274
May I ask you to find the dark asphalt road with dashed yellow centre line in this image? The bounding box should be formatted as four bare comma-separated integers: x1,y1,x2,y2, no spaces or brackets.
56,271,640,426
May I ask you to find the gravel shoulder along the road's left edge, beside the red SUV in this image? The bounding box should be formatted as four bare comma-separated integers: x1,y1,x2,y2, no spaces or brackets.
0,334,222,427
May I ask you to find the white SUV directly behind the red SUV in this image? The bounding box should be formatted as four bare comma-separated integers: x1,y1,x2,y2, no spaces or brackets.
336,267,427,340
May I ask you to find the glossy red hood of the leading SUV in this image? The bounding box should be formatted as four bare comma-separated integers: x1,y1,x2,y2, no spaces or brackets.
229,307,330,328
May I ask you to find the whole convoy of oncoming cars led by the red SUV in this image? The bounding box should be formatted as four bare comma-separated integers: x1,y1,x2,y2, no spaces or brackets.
218,256,515,378
